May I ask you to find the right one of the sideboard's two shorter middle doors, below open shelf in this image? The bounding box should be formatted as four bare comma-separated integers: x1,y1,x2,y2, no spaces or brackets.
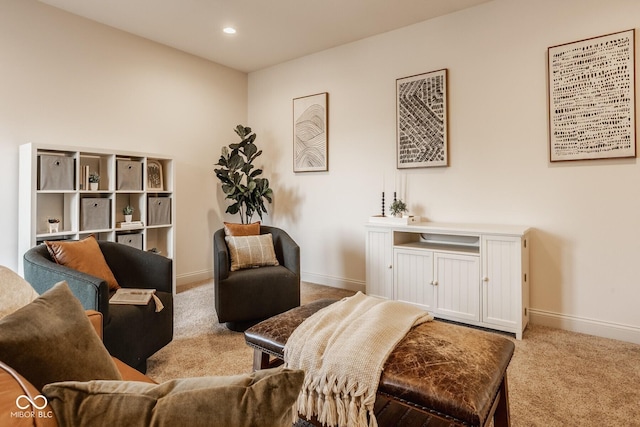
434,252,480,321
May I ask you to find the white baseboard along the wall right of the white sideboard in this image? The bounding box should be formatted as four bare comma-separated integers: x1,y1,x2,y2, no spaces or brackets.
529,308,640,344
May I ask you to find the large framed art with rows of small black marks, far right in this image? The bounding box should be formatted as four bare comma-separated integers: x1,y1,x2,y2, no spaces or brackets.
547,30,636,162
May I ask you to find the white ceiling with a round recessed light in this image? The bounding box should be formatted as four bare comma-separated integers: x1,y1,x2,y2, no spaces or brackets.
40,0,490,72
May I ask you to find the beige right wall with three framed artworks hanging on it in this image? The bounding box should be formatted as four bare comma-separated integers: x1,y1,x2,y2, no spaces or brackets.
249,0,640,342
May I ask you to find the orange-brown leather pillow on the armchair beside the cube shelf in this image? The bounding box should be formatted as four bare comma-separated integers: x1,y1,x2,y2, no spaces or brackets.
44,235,120,291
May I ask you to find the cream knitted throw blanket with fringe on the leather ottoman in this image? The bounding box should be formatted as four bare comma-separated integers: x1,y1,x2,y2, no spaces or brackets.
284,292,433,427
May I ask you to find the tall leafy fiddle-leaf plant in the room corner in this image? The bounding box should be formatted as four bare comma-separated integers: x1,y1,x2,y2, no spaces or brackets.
214,125,273,224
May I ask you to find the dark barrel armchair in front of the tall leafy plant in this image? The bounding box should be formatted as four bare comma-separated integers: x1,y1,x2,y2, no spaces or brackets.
213,225,300,331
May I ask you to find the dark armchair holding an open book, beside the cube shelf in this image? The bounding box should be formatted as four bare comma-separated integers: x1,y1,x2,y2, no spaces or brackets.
24,241,173,373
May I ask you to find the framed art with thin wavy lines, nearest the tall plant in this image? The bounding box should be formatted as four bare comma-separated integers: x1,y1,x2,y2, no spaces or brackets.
293,92,329,172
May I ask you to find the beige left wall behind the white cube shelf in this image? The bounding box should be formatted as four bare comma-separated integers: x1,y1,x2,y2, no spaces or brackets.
0,0,247,283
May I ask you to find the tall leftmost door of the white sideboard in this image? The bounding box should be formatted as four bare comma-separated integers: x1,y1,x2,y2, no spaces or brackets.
366,229,393,299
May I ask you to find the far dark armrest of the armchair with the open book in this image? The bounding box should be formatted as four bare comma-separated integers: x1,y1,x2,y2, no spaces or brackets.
98,241,173,293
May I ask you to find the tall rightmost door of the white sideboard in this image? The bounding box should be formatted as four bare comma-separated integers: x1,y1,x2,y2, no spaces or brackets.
482,236,522,330
